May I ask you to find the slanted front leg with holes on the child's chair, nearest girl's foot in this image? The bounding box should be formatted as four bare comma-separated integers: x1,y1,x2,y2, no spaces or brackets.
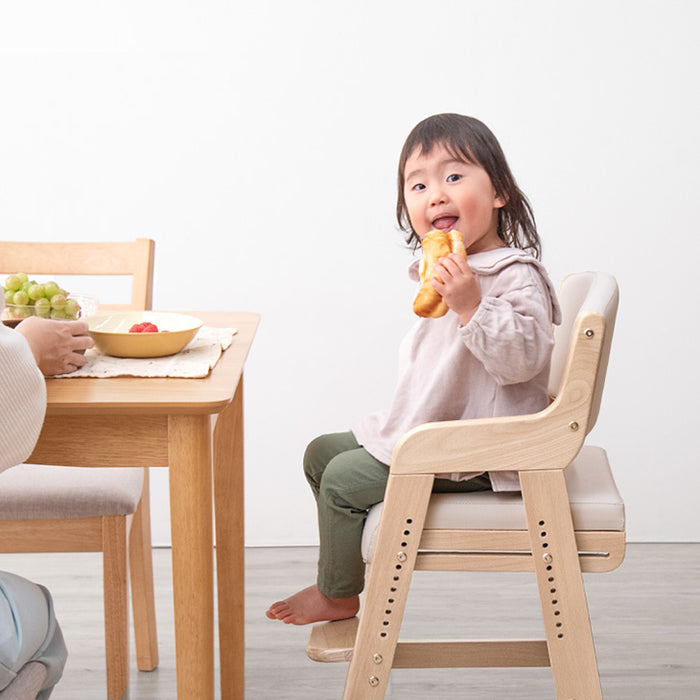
343,474,433,700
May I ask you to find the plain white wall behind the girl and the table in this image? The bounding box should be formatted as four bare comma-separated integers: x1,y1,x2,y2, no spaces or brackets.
0,0,700,545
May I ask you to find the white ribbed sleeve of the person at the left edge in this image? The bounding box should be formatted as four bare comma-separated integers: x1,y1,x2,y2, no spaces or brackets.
0,323,46,472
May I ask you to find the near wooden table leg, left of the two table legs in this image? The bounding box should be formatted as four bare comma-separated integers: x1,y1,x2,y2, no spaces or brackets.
168,415,214,700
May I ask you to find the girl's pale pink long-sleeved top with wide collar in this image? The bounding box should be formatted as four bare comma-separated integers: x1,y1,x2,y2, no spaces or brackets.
352,248,561,491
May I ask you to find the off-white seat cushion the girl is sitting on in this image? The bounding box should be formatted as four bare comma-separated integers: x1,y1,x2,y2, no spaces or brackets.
362,445,625,562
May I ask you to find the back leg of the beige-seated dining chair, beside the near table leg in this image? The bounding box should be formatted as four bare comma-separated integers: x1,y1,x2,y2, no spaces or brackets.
129,468,158,671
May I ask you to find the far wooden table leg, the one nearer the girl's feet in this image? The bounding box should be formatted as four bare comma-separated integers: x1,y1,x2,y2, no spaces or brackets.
214,377,245,700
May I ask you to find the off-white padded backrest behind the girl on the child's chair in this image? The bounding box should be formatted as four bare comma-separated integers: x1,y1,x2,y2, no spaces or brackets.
549,272,619,433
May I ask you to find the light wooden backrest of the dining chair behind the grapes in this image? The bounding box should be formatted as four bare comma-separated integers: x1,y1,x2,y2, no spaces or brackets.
0,238,155,310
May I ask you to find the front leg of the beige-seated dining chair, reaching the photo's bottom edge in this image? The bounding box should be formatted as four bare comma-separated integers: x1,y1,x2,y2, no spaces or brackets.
102,515,129,700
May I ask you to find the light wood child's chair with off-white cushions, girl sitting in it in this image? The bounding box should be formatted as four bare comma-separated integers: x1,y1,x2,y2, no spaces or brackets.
307,272,625,700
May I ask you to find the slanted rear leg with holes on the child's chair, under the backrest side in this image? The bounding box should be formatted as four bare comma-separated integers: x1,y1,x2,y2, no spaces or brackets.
520,470,603,700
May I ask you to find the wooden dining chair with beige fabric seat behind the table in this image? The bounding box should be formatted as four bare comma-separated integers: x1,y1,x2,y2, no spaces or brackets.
0,239,158,700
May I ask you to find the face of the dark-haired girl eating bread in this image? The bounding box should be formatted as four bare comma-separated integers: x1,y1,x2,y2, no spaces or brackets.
404,145,505,254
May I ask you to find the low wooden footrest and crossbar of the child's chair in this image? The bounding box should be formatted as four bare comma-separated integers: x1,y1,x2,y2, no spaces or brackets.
306,617,550,668
